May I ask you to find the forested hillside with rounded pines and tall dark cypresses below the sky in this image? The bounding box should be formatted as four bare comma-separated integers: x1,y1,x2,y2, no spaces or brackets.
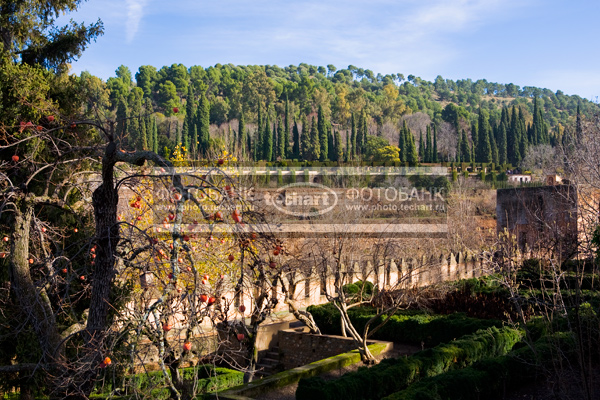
85,64,599,165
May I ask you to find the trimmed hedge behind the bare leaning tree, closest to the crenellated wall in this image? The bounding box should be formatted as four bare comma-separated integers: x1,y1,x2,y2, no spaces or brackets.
308,303,502,347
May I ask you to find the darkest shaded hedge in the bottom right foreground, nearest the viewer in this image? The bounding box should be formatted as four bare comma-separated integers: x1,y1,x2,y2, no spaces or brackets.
384,333,575,400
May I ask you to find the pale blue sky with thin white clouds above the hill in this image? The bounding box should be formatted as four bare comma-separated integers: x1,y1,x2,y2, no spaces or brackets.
58,0,600,101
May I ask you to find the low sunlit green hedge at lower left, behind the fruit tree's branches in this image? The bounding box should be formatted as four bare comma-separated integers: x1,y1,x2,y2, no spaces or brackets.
90,365,244,399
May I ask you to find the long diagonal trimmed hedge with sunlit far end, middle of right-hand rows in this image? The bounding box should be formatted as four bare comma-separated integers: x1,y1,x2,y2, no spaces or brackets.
296,327,522,400
